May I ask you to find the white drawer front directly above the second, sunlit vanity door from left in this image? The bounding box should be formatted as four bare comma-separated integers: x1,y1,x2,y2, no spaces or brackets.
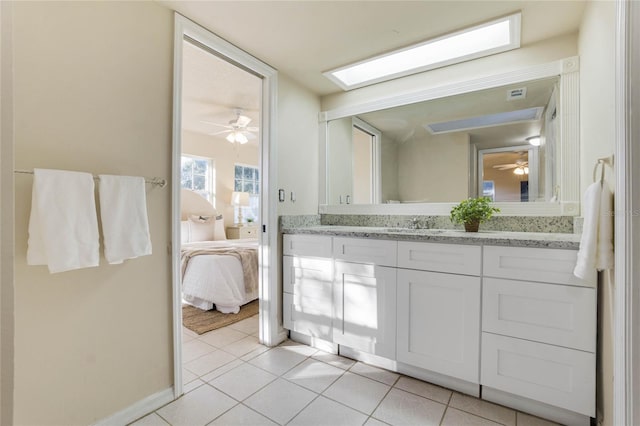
333,237,398,266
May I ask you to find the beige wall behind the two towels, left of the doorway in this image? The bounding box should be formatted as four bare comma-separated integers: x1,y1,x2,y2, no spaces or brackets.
11,2,173,425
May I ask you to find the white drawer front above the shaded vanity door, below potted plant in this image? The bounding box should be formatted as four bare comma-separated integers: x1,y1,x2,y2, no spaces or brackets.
398,241,482,275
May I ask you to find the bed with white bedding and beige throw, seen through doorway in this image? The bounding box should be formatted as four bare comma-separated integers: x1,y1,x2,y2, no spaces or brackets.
180,190,258,313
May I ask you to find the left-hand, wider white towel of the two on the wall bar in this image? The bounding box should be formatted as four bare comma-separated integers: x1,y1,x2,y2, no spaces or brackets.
27,169,100,273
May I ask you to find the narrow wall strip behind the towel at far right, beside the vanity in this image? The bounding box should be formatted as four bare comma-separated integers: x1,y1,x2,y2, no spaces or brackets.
579,1,616,425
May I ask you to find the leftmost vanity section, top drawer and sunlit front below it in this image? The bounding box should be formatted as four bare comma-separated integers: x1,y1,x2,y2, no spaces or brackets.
282,235,333,341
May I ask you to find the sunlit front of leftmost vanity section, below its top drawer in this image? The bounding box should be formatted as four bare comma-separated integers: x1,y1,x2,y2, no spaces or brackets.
282,256,333,341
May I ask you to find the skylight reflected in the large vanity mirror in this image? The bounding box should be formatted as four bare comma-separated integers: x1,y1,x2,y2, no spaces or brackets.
424,107,544,135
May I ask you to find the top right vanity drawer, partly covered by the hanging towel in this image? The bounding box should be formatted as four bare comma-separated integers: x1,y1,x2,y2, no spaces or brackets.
483,246,596,287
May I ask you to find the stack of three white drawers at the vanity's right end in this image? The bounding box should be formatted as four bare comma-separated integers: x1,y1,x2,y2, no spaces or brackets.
481,246,597,423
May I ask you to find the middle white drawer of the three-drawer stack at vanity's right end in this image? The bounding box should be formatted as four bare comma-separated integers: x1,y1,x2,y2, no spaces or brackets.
482,278,597,352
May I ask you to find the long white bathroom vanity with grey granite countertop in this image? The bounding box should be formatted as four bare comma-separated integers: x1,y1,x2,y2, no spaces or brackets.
283,226,597,424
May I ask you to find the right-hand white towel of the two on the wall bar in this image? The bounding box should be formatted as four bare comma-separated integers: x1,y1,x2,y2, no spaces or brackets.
98,175,151,264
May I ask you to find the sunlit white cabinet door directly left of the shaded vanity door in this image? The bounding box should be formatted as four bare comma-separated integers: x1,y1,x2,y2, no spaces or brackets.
333,261,396,360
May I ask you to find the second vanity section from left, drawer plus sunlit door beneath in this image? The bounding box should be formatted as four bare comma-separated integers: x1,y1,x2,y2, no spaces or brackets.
333,238,397,360
